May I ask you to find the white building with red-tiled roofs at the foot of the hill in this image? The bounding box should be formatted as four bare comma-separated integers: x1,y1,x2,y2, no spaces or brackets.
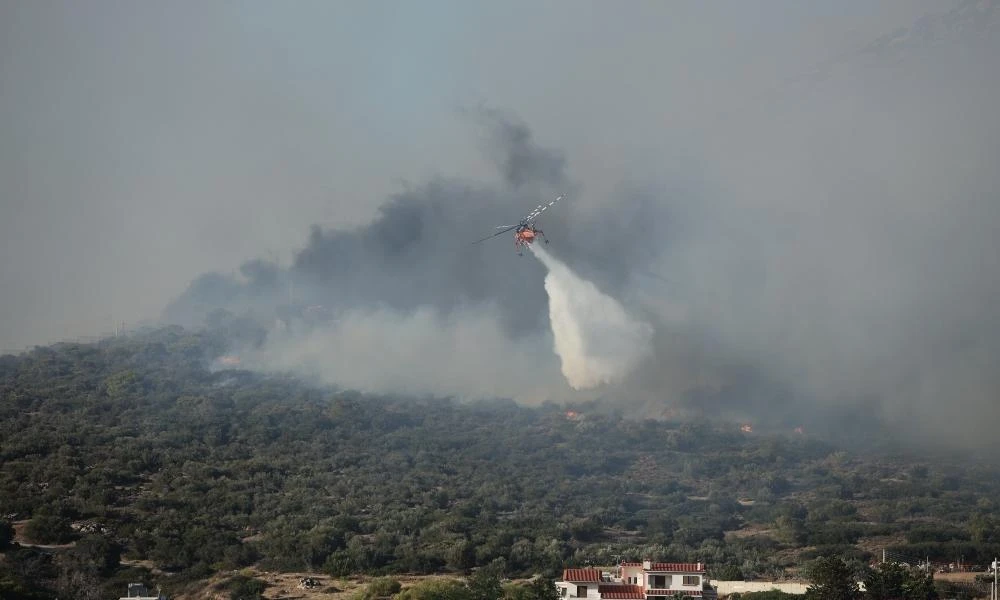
556,560,715,600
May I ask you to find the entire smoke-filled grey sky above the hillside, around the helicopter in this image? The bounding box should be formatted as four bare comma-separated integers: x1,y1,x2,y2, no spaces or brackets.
0,0,1000,447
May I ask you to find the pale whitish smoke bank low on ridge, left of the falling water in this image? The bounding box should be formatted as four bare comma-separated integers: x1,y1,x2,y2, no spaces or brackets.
234,306,558,403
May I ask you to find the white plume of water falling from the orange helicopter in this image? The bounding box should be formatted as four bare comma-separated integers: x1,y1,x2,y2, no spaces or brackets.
528,245,653,390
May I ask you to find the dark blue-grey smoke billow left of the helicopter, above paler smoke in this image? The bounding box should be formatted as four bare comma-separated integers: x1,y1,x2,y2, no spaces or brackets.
166,113,565,334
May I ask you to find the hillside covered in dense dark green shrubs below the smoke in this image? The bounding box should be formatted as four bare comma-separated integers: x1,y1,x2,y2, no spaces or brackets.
0,328,1000,594
